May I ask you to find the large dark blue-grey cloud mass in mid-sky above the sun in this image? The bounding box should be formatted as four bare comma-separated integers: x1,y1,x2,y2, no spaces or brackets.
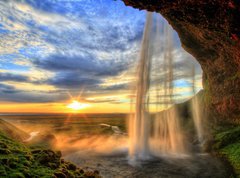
32,53,132,91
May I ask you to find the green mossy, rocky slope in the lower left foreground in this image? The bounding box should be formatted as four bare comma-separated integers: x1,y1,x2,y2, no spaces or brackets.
0,132,100,178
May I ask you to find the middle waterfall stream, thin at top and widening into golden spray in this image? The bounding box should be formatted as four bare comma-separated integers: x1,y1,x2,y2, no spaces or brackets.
151,16,187,155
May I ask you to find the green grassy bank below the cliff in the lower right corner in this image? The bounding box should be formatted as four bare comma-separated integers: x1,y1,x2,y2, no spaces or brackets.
213,126,240,178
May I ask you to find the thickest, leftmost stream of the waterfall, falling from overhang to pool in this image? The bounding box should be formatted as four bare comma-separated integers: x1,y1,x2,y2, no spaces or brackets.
129,12,152,161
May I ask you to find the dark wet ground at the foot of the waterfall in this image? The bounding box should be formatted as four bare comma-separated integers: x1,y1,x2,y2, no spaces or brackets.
65,153,229,178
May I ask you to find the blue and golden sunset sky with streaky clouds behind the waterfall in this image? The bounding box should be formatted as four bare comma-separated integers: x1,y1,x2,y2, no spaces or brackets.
0,0,201,113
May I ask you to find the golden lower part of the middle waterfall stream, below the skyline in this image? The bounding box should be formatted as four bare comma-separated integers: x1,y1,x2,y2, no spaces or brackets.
152,106,187,156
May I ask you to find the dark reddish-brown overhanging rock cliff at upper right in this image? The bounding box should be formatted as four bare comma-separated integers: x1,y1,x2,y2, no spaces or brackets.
123,0,240,123
